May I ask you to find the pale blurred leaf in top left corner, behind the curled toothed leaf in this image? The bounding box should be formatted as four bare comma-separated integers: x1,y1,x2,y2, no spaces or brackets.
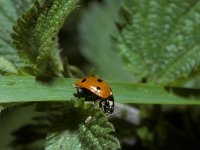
0,0,31,67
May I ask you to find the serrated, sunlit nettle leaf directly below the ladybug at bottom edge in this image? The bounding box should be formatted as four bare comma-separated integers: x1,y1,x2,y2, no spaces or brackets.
45,101,120,150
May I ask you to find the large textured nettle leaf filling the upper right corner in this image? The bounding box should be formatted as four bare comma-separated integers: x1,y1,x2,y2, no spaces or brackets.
115,0,200,83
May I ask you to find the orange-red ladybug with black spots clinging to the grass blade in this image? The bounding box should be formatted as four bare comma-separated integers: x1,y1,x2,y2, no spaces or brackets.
75,77,114,113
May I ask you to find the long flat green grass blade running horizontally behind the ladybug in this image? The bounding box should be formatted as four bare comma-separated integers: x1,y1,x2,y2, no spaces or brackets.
0,76,200,105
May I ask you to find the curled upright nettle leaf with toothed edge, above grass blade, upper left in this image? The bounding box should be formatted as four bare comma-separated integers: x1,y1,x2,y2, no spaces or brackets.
12,0,78,76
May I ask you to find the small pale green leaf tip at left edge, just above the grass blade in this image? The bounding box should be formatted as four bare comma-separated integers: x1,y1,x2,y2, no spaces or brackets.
0,56,18,74
